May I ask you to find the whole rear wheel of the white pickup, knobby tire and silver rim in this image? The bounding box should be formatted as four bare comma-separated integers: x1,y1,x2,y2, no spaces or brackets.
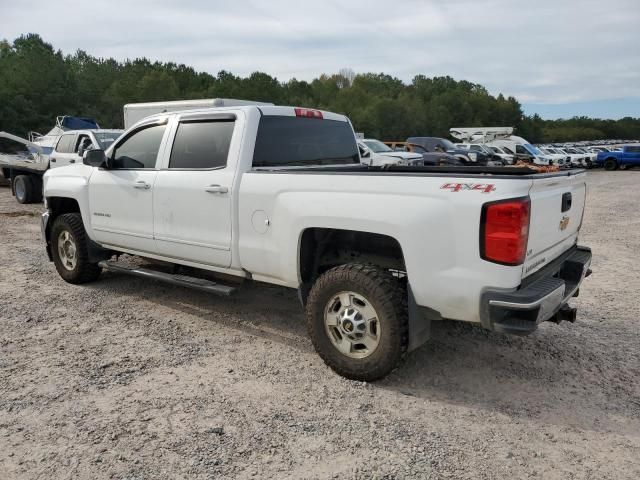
306,264,408,381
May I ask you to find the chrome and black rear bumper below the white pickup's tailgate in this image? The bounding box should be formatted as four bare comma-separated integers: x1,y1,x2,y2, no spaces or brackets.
480,246,591,335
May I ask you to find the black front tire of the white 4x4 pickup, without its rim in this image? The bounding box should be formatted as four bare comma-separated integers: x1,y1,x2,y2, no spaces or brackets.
50,213,102,284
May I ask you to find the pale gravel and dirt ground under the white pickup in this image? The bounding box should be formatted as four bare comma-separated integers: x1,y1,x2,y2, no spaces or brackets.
0,171,640,479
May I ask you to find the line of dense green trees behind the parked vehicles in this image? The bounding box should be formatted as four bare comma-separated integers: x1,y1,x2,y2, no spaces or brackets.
0,34,640,143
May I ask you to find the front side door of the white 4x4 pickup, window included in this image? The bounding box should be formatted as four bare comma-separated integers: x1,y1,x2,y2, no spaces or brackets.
89,120,167,253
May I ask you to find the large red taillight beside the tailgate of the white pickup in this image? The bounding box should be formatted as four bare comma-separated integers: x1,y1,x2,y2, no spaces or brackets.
480,197,531,265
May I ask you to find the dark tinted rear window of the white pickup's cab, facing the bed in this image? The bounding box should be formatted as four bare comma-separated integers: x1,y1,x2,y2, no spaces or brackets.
253,115,360,167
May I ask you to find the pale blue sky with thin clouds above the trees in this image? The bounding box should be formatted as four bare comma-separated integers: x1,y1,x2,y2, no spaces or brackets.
0,0,640,118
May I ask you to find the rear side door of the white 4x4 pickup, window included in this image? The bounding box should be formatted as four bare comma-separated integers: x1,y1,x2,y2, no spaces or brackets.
153,113,241,267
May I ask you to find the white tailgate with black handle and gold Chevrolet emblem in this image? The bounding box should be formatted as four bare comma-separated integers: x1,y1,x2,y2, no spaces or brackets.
522,172,587,277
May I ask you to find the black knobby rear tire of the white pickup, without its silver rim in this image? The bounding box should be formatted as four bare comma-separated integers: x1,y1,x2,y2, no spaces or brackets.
306,264,408,382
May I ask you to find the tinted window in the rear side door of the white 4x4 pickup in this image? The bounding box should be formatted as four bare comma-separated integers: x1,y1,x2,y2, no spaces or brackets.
169,120,235,169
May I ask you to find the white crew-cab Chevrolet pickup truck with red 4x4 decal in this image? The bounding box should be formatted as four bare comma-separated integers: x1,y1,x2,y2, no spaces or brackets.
42,106,591,381
